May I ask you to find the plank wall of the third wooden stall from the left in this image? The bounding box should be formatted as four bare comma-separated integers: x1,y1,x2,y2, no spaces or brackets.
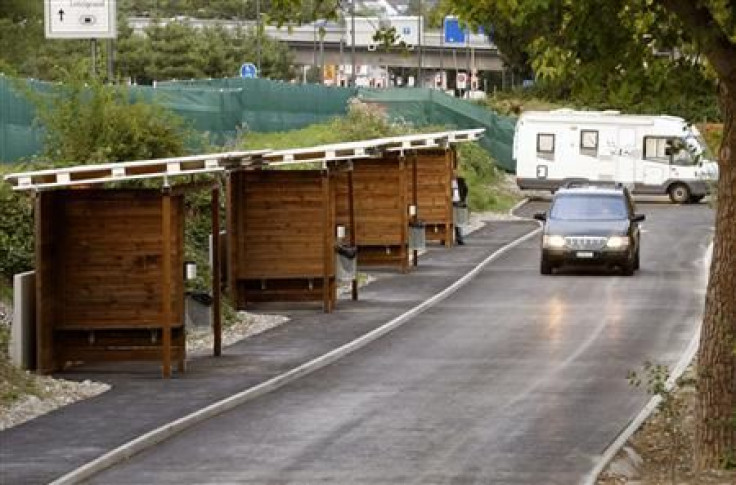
337,154,411,271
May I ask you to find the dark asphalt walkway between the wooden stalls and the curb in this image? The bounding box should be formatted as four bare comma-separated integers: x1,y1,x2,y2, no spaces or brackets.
0,221,537,484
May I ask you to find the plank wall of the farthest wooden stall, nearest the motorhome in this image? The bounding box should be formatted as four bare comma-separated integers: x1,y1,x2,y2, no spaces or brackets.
407,149,455,246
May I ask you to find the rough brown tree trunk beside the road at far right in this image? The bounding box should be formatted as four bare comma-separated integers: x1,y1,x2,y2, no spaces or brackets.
696,80,736,470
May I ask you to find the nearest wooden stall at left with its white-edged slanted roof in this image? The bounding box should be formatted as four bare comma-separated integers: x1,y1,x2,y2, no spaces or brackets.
6,152,262,377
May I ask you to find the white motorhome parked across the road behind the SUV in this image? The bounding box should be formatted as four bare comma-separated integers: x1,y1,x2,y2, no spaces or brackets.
513,109,718,203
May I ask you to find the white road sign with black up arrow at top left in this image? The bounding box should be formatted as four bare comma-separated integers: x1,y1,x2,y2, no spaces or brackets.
44,0,117,39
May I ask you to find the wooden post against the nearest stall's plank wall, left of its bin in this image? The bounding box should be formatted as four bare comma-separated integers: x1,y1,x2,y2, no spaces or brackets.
161,187,173,378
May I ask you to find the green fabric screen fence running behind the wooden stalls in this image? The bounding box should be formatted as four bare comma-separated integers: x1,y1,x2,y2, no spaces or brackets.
0,76,515,171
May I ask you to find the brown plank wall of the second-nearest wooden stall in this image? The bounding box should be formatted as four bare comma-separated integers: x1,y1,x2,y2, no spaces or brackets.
228,170,337,311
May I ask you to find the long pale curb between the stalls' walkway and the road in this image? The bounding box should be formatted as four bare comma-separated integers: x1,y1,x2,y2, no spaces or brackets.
51,224,541,485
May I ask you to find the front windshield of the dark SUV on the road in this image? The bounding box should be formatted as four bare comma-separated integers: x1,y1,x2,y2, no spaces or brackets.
550,194,628,221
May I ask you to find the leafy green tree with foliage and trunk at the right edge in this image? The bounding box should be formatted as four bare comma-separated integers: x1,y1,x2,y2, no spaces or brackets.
456,0,736,468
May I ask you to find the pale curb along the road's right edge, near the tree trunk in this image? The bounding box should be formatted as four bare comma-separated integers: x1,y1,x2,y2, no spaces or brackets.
580,243,713,485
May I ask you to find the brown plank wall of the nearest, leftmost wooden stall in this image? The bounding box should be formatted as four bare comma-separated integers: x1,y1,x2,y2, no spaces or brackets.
36,190,185,372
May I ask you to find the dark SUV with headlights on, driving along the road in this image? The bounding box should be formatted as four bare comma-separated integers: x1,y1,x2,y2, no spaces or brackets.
534,186,645,276
